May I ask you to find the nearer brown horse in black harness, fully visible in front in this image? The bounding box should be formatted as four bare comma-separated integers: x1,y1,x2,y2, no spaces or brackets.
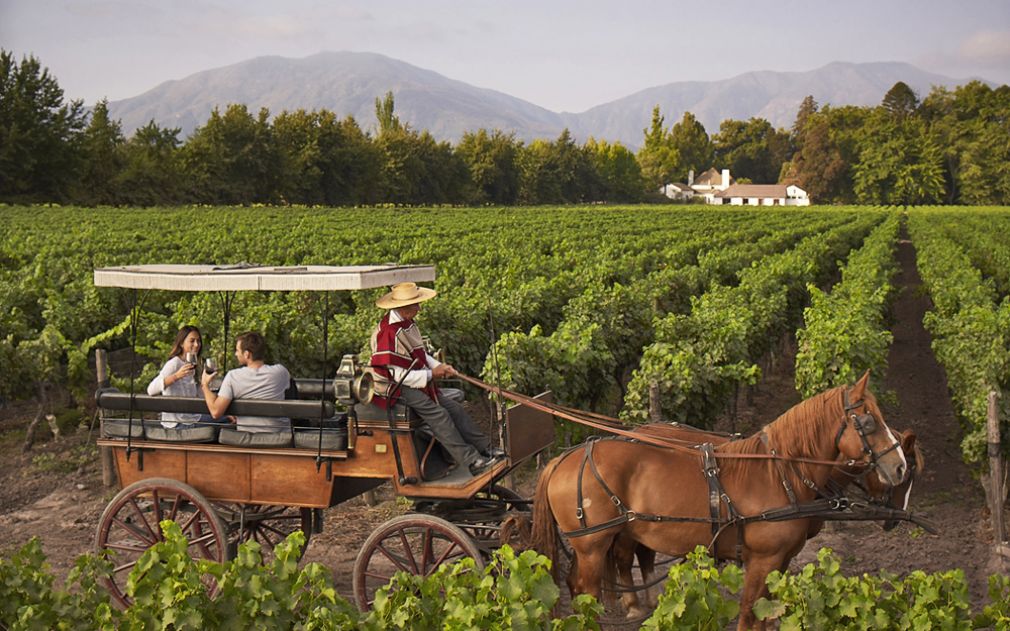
532,374,908,629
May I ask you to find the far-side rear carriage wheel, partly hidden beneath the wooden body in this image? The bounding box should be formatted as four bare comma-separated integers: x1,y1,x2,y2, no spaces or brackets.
214,502,312,564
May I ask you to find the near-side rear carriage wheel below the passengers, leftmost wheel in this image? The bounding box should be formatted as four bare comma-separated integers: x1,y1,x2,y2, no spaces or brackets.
95,478,228,608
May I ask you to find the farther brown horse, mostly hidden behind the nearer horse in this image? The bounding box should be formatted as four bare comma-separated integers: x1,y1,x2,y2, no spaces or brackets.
607,423,924,618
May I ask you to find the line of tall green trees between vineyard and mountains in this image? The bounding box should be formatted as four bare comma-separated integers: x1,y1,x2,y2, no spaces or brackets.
0,49,1010,206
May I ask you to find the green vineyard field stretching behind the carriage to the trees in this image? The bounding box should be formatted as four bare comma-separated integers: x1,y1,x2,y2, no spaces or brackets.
0,206,1010,625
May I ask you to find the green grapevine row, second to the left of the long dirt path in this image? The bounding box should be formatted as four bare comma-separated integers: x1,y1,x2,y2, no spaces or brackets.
621,212,883,425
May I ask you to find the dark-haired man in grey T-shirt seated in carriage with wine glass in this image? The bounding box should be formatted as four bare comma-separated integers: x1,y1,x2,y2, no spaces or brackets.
200,332,291,432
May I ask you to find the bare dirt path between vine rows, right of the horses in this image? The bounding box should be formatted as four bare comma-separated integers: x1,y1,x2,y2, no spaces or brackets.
794,236,999,608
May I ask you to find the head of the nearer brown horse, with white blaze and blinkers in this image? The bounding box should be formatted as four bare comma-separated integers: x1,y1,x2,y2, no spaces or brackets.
834,371,908,487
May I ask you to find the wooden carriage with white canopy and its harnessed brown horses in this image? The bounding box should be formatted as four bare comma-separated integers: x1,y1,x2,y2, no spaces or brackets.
95,266,928,626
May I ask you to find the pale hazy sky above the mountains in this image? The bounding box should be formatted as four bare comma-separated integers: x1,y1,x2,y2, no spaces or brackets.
0,0,1010,112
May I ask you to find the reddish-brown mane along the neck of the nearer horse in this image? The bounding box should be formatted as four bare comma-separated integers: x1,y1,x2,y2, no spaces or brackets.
717,386,848,486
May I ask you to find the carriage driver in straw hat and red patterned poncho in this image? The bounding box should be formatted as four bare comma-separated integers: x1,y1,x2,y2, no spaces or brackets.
370,283,504,476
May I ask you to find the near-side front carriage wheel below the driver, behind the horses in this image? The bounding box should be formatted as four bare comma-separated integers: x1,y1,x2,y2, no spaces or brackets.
354,514,484,611
